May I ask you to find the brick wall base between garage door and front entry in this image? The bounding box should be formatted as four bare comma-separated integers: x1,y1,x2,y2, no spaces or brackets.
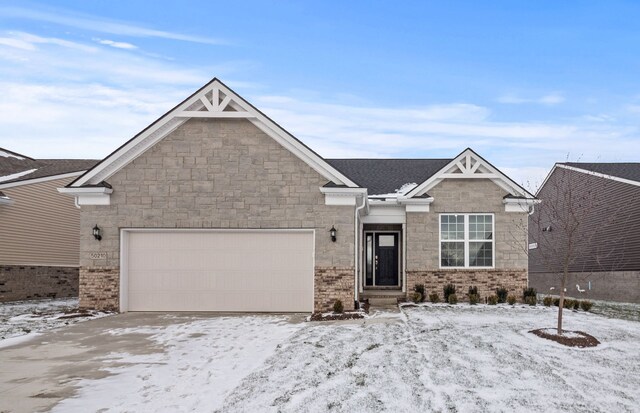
313,267,355,311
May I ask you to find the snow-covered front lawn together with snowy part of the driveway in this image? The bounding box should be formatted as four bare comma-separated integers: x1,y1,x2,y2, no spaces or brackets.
54,304,640,413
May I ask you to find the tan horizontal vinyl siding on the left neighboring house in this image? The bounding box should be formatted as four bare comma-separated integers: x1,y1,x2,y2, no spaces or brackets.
0,178,80,267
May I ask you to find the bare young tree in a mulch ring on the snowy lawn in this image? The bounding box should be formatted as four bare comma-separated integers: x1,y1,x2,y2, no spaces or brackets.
528,164,629,335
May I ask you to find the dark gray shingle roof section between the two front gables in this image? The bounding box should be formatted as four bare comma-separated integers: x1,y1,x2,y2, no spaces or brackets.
326,159,451,195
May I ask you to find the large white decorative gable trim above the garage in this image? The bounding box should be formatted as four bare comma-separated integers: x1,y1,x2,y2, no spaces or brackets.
68,78,358,187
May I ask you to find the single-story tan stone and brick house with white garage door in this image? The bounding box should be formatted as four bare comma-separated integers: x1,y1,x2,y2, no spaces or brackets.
59,79,537,312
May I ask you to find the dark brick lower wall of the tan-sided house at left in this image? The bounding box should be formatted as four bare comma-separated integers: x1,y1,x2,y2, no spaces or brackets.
0,265,78,302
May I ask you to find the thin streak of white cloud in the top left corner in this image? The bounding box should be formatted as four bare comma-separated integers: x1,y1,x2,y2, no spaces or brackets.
0,7,227,45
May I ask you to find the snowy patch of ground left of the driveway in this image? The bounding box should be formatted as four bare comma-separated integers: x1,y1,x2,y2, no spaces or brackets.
0,298,107,347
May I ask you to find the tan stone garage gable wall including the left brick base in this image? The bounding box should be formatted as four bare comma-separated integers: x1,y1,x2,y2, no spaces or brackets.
80,119,355,308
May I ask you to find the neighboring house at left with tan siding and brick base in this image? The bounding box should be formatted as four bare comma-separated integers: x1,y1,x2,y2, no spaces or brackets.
0,148,97,302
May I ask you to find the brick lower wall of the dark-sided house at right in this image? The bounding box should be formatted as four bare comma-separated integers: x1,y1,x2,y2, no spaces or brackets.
529,271,640,304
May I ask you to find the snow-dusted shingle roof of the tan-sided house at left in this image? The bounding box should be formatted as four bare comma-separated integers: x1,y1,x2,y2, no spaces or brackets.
0,148,98,184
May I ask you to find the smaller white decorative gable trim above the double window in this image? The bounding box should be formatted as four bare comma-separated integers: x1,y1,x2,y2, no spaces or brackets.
405,148,535,199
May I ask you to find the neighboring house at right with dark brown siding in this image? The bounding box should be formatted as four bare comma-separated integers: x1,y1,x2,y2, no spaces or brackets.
529,162,640,303
